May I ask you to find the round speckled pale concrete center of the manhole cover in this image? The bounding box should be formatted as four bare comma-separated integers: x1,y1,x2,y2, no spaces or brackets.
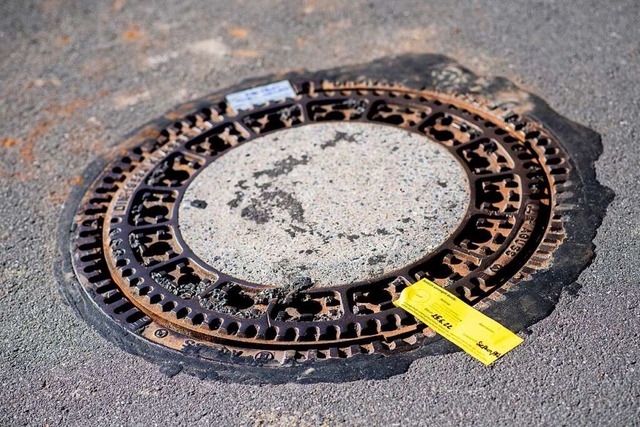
179,122,469,286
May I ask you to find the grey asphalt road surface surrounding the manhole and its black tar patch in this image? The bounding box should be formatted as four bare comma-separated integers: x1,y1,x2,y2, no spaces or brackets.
0,0,640,425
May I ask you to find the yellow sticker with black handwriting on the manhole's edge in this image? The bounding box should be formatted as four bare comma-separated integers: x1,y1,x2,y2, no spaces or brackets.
393,279,523,366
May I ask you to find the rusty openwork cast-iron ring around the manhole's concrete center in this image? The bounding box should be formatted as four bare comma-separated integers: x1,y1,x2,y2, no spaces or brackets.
70,81,570,366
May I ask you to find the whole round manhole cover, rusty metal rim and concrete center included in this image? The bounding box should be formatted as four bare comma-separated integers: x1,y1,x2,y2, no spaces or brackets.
58,57,608,380
